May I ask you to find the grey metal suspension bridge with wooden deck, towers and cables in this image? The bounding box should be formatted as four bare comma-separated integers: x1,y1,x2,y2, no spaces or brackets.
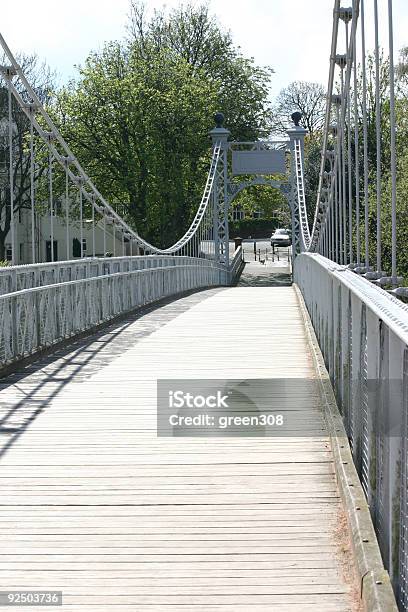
0,0,408,612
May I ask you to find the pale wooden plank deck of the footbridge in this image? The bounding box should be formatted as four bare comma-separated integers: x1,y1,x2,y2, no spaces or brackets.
0,287,357,612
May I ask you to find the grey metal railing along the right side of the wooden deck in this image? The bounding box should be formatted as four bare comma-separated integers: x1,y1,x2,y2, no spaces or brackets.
294,253,408,610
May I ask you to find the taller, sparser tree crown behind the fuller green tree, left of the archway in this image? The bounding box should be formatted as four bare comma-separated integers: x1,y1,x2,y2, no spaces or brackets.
128,0,273,140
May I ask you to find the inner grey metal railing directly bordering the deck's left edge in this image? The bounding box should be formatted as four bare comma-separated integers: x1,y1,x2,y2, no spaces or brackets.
0,258,230,367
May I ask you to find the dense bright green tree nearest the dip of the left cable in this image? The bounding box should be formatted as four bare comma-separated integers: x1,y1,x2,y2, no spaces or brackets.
56,43,216,244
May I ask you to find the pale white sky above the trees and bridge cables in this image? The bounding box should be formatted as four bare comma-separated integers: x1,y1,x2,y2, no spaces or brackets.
0,0,408,98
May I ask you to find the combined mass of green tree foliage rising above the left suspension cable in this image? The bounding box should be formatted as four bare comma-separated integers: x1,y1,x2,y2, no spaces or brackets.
53,3,271,245
